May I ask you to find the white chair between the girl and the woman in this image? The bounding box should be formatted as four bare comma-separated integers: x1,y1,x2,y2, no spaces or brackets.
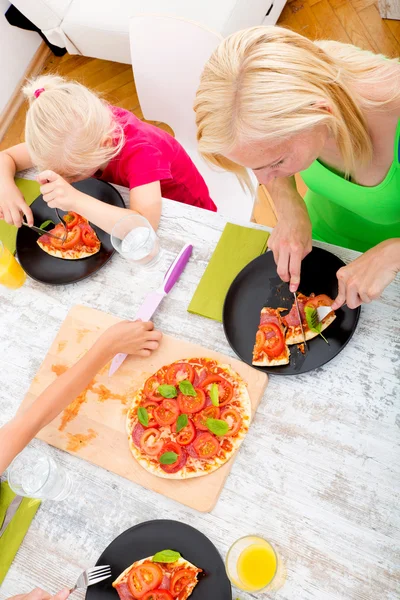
130,15,254,221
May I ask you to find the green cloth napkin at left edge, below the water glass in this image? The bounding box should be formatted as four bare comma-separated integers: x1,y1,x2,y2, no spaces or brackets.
0,481,40,585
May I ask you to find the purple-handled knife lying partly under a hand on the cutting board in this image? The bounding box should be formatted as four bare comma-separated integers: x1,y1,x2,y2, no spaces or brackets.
108,244,193,377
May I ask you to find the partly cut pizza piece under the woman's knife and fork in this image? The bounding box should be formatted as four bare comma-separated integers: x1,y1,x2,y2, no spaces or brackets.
282,293,336,346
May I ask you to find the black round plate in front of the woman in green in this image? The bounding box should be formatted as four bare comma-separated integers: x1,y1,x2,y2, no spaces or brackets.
223,248,361,375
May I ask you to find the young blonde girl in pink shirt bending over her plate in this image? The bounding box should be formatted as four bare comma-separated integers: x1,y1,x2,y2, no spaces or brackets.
0,75,217,233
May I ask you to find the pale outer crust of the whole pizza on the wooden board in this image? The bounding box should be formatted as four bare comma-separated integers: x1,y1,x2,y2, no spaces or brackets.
126,359,252,480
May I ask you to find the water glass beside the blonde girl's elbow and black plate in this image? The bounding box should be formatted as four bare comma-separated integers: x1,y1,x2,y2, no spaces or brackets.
111,215,160,266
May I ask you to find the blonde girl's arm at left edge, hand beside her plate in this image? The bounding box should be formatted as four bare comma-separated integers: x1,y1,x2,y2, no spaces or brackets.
0,144,33,227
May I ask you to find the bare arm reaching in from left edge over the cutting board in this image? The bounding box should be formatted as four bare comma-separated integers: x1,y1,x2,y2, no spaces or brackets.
0,321,161,474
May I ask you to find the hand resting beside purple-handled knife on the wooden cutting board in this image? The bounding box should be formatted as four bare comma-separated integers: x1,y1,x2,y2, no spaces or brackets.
100,321,162,357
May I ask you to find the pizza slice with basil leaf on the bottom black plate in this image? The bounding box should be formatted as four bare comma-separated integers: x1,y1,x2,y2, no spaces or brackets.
112,550,202,600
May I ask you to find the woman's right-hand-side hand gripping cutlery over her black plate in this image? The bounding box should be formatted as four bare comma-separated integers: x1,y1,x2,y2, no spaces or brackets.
332,238,400,310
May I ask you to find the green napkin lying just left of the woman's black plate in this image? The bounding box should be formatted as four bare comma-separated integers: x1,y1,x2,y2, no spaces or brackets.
188,223,269,322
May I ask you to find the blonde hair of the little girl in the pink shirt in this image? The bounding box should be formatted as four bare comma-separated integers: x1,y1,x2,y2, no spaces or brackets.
23,75,125,178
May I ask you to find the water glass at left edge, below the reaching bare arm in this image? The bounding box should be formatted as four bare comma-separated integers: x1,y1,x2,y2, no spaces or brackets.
7,448,72,501
